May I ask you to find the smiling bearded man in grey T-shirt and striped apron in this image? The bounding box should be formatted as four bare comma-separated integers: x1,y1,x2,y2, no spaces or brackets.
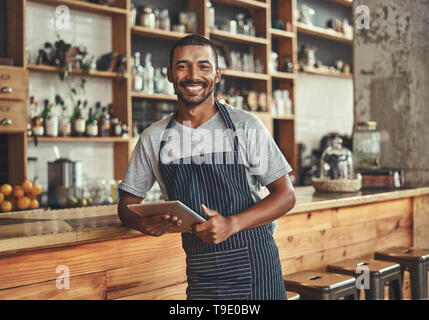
119,35,295,299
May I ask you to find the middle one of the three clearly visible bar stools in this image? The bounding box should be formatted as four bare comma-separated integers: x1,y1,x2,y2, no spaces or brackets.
326,259,402,300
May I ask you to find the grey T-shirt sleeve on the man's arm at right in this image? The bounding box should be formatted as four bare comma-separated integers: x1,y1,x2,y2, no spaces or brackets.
246,116,292,186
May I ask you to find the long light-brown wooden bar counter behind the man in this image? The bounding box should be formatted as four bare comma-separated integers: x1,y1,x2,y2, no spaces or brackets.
0,187,429,299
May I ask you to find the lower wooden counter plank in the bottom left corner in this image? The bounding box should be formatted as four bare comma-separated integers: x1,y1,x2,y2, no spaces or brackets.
0,272,106,300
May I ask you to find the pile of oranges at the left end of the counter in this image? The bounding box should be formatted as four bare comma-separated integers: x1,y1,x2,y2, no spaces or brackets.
0,180,43,212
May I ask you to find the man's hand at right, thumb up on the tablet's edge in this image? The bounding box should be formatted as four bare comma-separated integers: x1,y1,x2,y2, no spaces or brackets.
192,205,235,244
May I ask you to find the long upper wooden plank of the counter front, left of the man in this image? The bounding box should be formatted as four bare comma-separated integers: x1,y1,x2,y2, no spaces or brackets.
0,234,183,289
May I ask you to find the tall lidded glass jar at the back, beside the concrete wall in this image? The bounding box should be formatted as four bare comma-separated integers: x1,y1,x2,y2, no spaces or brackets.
353,121,381,169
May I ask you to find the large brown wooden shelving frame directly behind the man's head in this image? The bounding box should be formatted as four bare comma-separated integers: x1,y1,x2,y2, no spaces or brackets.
7,0,297,179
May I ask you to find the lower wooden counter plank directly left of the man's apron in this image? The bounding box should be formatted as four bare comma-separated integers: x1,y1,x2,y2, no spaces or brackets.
107,252,186,299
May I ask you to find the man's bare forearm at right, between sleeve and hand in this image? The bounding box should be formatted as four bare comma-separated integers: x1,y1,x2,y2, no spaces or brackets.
230,190,295,233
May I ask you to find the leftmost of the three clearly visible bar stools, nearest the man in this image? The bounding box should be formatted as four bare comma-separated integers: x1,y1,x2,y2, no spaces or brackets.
284,271,358,300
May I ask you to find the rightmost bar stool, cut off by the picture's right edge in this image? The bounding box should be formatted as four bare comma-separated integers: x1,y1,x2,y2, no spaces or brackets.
374,247,429,300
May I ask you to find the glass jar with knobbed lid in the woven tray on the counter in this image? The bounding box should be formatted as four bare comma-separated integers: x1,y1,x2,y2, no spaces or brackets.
320,137,355,180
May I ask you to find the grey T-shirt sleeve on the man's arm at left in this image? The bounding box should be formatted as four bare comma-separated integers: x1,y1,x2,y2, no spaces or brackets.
119,136,155,198
